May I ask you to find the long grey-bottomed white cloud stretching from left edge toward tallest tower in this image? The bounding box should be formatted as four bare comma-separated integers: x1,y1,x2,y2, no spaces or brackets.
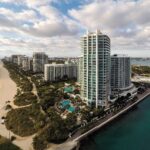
0,6,80,37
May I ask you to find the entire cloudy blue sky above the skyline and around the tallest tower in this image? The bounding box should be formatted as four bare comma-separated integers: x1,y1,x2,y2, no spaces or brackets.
0,0,150,57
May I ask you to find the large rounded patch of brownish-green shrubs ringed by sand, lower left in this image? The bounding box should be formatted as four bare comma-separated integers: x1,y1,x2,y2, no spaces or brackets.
5,104,46,136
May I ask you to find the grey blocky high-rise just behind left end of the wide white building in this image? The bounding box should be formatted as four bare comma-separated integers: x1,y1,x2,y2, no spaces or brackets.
33,52,48,73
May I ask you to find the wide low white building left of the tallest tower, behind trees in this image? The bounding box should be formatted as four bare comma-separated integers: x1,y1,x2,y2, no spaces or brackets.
44,64,77,81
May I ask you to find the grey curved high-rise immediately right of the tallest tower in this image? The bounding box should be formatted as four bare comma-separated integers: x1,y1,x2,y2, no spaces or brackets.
111,55,131,92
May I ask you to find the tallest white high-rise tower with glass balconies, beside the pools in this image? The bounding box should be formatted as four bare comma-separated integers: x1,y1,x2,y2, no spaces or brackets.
81,31,110,108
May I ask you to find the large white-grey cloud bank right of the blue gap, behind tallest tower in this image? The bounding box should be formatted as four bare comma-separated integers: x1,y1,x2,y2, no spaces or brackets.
68,0,150,52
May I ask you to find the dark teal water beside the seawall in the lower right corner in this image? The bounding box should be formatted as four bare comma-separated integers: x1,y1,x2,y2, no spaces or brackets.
80,97,150,150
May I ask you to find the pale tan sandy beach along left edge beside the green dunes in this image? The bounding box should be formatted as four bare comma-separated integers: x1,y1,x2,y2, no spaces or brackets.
0,61,33,150
